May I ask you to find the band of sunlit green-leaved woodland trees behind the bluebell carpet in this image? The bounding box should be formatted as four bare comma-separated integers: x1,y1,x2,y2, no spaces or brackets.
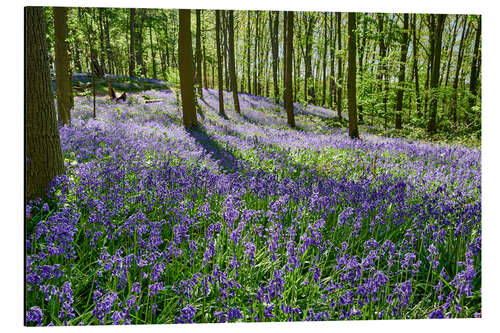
26,7,481,200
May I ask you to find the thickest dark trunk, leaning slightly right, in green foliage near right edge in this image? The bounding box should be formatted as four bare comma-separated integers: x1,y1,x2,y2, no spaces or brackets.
427,14,446,134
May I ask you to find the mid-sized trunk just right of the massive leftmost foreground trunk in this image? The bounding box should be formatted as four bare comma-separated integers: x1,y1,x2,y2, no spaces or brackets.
53,7,73,125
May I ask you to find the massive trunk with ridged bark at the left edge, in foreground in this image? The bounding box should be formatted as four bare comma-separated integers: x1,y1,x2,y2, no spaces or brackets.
24,7,64,204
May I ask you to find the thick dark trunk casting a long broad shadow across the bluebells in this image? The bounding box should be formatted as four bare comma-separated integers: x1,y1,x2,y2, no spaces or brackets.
178,9,198,128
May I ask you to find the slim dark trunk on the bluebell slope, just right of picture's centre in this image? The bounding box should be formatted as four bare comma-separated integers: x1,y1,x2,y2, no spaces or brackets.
283,11,295,128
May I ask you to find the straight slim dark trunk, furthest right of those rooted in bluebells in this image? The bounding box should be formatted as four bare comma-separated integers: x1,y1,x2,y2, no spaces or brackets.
347,13,359,139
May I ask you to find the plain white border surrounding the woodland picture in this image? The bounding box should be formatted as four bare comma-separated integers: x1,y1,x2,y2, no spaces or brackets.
0,0,500,332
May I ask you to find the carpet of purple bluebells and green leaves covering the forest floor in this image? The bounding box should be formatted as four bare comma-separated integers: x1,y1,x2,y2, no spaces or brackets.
26,83,481,325
